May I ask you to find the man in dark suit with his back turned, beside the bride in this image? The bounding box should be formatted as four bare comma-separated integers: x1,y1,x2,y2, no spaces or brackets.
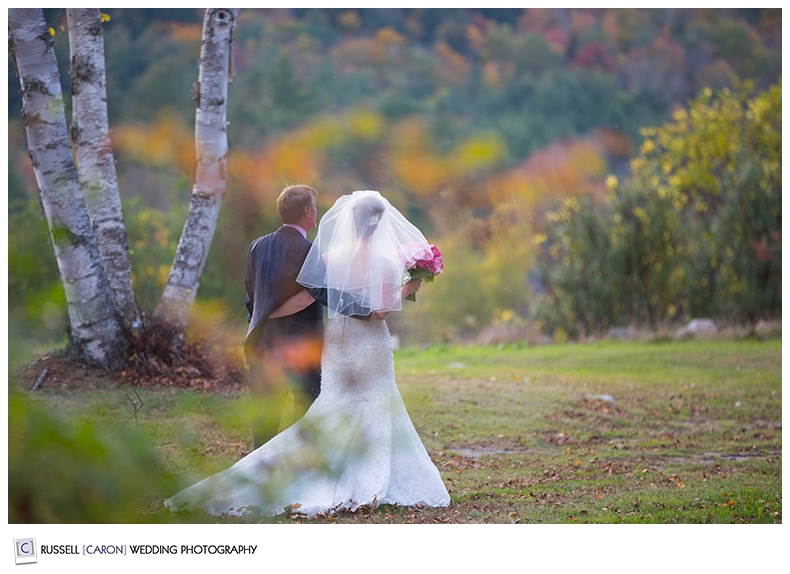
244,185,326,448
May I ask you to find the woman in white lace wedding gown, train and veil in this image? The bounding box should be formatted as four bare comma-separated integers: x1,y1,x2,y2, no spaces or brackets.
165,190,450,517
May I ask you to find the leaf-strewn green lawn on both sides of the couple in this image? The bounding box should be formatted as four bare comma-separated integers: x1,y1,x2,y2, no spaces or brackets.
9,341,782,524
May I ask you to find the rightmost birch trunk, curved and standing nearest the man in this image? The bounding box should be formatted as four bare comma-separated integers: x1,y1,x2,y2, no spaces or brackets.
154,8,238,337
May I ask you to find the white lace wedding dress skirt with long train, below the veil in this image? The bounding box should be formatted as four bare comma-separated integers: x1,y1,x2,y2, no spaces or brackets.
165,317,450,517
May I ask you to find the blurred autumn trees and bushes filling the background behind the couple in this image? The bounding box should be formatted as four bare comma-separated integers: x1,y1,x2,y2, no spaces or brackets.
9,9,781,354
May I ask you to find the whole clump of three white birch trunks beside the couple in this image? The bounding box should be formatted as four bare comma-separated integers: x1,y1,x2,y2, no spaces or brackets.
8,8,238,369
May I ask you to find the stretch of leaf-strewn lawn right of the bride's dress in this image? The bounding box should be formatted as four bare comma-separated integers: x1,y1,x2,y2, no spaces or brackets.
398,342,782,523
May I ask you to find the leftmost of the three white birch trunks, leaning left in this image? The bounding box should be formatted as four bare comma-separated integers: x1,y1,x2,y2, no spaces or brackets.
8,8,129,369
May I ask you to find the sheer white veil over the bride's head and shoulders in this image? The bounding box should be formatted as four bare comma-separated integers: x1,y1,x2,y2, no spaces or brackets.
296,190,431,318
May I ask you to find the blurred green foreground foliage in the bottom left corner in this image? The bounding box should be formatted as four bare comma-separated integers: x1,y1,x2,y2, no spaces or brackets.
8,388,176,524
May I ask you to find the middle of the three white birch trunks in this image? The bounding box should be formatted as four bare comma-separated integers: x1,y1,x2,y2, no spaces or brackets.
67,8,140,330
